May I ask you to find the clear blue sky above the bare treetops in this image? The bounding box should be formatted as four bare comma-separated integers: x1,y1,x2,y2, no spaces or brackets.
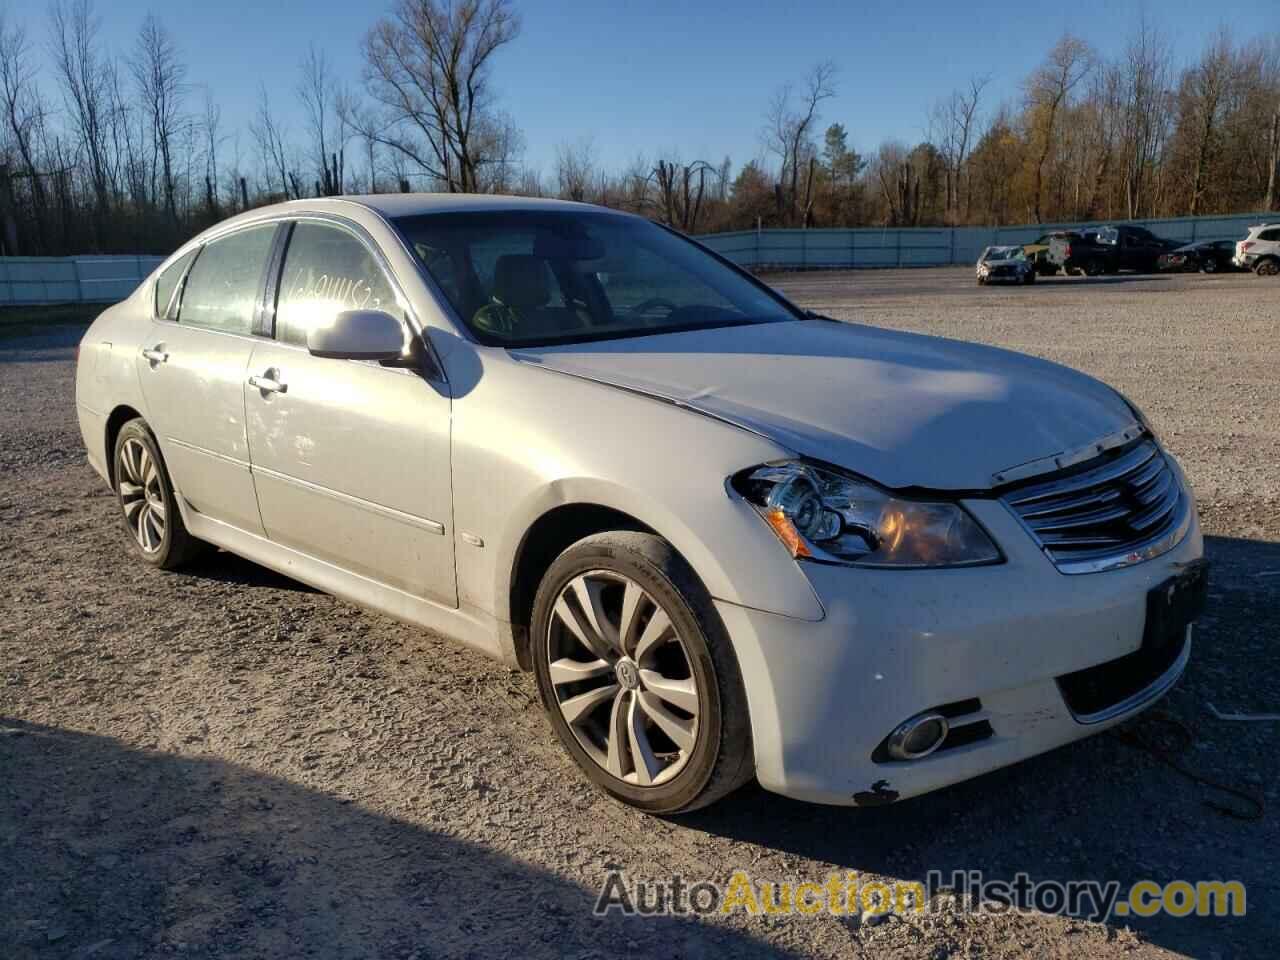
45,0,1280,174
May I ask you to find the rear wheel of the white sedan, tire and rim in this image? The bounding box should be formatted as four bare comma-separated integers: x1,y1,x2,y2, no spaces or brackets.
111,417,207,570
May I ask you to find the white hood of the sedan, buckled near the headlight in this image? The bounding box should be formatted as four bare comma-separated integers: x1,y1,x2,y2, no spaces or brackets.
512,320,1134,490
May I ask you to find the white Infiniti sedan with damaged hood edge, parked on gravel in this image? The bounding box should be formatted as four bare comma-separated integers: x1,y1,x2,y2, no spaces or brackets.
76,195,1206,813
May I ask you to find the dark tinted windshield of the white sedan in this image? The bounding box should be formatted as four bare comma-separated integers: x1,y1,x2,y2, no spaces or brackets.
396,210,799,347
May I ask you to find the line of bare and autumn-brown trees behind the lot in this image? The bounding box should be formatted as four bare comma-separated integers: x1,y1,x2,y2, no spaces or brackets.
0,0,1280,255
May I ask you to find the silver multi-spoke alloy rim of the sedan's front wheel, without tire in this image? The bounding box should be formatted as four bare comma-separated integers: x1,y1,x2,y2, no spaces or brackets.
547,570,701,786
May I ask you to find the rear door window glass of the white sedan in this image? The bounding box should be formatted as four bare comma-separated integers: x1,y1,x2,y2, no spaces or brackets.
178,224,275,335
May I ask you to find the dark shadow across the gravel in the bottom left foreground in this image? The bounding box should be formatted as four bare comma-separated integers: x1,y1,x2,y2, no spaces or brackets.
0,717,786,960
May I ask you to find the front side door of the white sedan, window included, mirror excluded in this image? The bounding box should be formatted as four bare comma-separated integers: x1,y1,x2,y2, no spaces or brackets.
243,220,457,607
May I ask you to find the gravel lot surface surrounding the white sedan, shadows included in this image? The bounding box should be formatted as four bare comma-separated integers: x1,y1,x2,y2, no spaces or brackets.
0,270,1280,960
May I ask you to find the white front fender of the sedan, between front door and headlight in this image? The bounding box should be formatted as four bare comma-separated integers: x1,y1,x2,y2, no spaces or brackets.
445,343,823,621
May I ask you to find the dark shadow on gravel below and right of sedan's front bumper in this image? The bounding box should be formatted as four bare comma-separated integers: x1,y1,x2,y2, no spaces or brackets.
678,536,1280,957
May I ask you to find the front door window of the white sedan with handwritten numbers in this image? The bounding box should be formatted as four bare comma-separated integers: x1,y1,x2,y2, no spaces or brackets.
275,221,402,347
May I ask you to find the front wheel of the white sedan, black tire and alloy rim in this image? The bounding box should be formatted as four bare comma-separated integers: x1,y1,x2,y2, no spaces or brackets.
531,531,755,814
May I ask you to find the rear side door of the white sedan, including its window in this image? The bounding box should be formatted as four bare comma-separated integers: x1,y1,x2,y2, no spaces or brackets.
137,224,276,535
